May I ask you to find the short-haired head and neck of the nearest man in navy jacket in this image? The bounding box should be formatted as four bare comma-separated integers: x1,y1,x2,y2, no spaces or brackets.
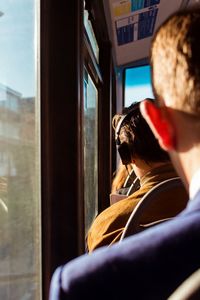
141,9,200,187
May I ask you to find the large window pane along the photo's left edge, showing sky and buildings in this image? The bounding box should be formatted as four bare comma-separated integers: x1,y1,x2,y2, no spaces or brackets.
0,0,41,300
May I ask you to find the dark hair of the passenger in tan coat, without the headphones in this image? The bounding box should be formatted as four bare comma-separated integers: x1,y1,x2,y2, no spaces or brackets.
113,99,169,163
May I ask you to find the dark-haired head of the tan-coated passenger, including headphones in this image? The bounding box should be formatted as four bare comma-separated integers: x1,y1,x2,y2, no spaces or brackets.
113,102,169,164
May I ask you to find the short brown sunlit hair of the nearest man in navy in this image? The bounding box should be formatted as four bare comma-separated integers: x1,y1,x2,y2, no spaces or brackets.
151,9,200,116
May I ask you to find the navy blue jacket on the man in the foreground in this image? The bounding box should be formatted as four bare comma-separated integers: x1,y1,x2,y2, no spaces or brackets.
50,192,200,300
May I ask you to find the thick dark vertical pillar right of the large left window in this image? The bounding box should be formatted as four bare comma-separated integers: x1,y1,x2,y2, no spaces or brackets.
40,0,84,299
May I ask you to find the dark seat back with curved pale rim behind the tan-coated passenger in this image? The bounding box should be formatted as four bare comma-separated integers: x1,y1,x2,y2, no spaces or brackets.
120,177,188,240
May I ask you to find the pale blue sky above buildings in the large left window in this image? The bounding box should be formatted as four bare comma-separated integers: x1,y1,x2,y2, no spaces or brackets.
0,0,35,97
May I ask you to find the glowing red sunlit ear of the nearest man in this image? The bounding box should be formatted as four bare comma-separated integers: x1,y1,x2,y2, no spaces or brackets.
140,100,175,151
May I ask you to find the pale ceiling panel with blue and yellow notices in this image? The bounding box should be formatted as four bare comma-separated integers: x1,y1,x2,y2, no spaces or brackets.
104,0,199,66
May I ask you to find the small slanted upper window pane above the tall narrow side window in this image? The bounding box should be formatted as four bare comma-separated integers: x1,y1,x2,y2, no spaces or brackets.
84,3,99,62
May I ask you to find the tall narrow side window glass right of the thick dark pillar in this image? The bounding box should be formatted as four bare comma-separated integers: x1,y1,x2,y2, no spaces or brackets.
84,70,98,232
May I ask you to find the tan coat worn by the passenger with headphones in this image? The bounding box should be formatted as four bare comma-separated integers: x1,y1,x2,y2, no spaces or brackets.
87,163,187,252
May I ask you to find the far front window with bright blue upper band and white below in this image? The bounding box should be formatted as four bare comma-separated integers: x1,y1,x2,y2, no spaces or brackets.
124,65,154,107
